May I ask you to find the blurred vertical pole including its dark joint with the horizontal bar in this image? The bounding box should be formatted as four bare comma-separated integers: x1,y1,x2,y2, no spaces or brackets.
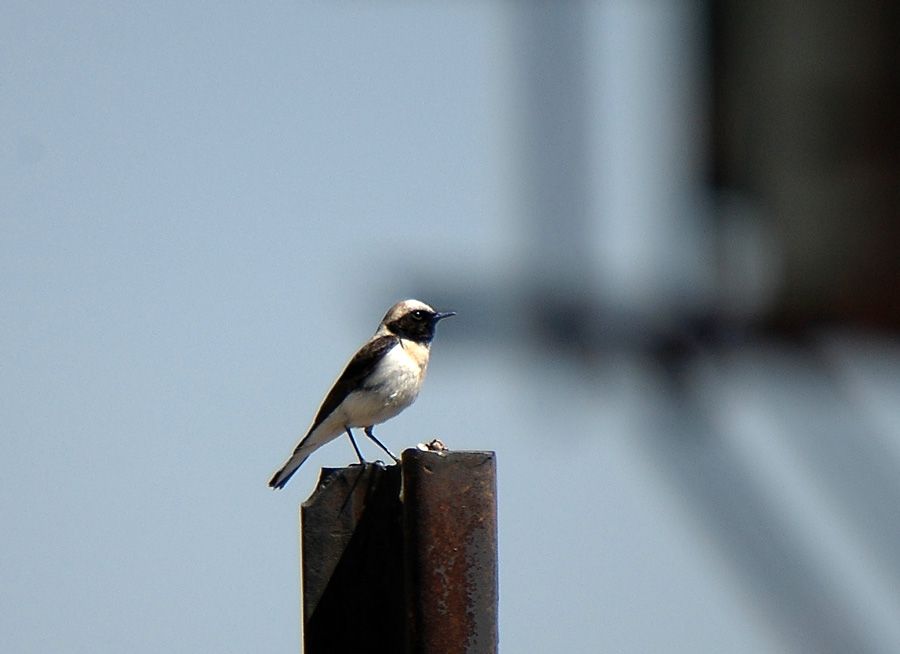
512,0,593,350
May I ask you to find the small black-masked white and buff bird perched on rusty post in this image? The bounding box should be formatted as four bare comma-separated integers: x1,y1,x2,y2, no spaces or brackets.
269,300,456,489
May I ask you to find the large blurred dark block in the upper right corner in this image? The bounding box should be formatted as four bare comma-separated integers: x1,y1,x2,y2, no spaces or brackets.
710,0,900,330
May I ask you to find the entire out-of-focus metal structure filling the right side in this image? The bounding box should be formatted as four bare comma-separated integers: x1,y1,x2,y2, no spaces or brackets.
426,0,900,654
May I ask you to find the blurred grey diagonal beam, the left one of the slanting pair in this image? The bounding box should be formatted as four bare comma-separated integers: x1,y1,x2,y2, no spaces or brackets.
644,364,882,654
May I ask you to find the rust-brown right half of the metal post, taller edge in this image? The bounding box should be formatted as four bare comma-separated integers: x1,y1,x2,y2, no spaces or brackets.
402,449,499,654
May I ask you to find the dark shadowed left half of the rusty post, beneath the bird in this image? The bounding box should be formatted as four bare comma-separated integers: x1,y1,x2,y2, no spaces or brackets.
300,463,405,654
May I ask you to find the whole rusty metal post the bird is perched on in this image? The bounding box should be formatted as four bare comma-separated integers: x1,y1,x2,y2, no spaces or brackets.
300,450,498,654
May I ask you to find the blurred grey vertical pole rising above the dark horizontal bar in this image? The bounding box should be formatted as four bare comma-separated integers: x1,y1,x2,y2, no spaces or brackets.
515,0,590,289
